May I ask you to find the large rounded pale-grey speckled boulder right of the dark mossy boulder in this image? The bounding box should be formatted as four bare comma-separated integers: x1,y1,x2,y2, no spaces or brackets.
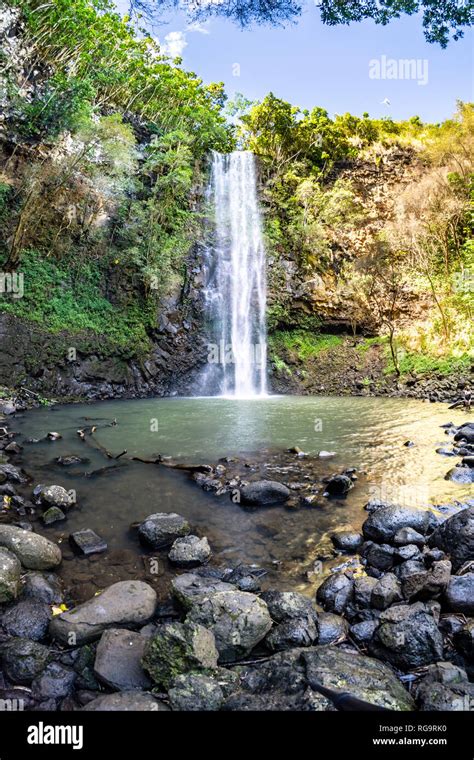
186,589,272,662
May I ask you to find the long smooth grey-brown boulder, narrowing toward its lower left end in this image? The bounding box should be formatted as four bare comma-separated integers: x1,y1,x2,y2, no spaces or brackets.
50,581,157,646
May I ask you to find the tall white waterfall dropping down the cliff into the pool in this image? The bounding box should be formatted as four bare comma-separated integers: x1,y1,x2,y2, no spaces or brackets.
200,151,267,397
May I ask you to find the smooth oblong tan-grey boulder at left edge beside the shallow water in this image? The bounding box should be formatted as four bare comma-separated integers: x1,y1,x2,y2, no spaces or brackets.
0,525,62,570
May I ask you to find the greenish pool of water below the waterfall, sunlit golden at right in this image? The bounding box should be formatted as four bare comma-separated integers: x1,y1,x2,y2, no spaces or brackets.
8,396,473,598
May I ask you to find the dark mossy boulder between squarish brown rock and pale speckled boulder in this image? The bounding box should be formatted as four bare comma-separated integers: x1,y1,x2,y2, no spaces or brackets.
142,620,218,689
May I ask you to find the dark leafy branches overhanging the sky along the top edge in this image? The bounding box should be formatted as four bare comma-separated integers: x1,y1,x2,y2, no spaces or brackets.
130,0,473,47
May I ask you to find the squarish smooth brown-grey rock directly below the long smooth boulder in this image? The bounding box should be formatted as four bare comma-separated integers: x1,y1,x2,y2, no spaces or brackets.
94,628,151,691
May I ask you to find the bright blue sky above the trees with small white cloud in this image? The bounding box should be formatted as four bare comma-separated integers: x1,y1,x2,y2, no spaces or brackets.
116,0,474,122
